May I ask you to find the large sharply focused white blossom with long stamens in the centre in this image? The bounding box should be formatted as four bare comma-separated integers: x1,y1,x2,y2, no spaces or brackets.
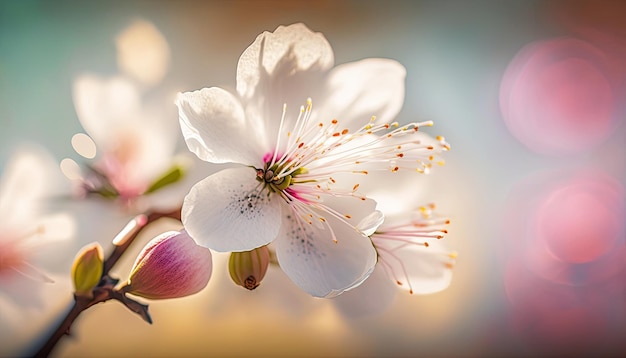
177,24,447,297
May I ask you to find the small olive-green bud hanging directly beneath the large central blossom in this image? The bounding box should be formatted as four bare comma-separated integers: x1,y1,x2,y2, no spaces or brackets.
228,246,270,290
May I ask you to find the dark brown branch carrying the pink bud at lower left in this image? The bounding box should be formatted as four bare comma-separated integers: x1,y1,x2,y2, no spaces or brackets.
34,208,180,357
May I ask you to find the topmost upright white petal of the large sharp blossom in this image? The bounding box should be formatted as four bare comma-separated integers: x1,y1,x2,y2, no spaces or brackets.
237,24,334,150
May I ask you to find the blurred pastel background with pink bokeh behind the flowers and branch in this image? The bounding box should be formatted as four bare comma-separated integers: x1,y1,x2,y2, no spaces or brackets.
0,0,626,357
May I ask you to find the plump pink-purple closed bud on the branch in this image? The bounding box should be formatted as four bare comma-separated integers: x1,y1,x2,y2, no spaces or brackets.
125,230,213,299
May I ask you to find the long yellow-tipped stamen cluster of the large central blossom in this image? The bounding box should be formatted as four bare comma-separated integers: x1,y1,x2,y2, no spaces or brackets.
255,99,449,243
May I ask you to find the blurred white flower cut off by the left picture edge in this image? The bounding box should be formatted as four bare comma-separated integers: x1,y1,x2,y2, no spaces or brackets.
0,147,75,356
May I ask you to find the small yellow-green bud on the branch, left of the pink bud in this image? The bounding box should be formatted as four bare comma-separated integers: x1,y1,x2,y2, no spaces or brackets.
72,242,104,298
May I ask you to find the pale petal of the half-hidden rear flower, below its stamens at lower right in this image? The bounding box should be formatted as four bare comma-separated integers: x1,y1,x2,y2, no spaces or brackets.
374,241,452,295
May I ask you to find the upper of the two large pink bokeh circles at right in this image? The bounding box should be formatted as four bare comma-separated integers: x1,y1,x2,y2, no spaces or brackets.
500,38,619,155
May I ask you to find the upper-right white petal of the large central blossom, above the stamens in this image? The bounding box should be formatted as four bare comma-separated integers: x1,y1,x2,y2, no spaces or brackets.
313,58,406,129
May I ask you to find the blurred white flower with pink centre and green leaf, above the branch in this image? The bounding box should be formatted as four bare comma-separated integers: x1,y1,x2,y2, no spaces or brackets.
66,75,189,210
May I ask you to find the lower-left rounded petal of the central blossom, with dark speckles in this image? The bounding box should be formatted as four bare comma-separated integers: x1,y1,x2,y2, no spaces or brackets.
182,168,282,252
